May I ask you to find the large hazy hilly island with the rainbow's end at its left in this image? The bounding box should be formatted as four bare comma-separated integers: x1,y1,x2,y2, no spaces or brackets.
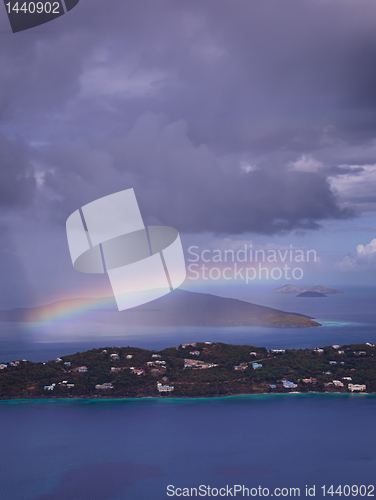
0,289,321,328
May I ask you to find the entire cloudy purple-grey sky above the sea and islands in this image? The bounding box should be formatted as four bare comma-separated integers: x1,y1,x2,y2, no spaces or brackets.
0,0,376,309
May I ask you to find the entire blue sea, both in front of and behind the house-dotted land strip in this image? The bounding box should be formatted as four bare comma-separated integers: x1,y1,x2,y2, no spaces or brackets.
0,289,376,500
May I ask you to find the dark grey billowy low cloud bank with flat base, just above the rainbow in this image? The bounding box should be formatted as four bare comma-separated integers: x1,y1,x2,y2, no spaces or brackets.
32,114,353,234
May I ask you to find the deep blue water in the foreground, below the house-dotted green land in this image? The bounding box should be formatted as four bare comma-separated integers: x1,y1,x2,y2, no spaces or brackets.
0,394,376,500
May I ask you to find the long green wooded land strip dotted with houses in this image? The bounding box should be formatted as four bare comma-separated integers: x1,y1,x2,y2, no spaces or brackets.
0,342,376,400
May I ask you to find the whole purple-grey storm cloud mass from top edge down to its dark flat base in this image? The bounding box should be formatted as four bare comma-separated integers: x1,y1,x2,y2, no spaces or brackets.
0,0,376,234
